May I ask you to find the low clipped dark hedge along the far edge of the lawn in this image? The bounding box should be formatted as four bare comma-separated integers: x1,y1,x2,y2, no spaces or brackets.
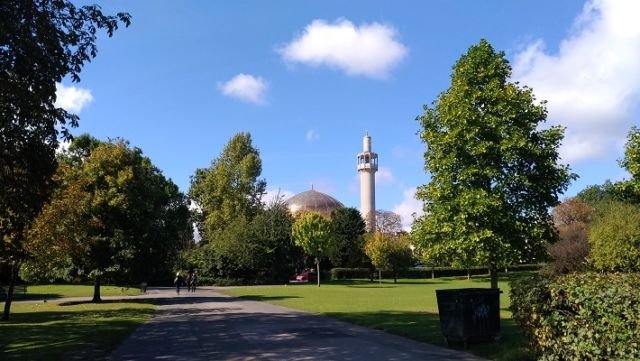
331,264,542,280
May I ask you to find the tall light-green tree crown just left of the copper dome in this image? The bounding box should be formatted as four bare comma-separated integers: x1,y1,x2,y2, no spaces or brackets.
189,133,266,242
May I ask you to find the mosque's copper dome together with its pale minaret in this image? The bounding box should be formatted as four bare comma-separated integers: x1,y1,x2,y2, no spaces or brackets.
285,133,378,232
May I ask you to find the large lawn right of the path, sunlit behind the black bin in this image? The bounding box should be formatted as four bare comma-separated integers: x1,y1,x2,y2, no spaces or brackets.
224,274,535,360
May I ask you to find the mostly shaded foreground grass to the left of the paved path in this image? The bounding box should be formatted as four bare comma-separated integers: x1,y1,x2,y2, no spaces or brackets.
0,293,154,360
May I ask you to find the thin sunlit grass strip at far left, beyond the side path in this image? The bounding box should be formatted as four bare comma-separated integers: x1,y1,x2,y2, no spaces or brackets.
13,285,142,301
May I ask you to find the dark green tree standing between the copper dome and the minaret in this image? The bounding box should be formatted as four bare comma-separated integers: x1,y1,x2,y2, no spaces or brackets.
331,208,368,267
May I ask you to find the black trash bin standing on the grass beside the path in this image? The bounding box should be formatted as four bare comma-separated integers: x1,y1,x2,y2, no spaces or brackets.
436,288,501,348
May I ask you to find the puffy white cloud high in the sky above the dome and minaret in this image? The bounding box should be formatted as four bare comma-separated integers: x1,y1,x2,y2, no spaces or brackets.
280,19,408,78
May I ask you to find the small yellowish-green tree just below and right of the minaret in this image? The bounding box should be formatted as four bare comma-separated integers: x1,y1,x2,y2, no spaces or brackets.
364,232,413,282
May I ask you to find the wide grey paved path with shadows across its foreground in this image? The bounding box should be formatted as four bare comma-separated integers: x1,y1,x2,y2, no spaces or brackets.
111,290,482,361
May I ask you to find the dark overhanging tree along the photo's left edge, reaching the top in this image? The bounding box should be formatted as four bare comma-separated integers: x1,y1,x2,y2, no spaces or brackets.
0,0,130,320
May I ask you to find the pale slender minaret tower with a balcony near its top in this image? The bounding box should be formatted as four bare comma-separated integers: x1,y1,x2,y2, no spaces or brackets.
358,133,378,232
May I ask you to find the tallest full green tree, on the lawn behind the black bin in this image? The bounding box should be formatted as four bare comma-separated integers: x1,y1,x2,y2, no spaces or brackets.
413,40,575,288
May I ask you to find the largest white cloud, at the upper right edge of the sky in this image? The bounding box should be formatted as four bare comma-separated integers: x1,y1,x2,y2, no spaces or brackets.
513,0,640,162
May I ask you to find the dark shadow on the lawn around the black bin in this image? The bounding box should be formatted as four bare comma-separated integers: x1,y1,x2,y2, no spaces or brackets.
325,311,535,361
